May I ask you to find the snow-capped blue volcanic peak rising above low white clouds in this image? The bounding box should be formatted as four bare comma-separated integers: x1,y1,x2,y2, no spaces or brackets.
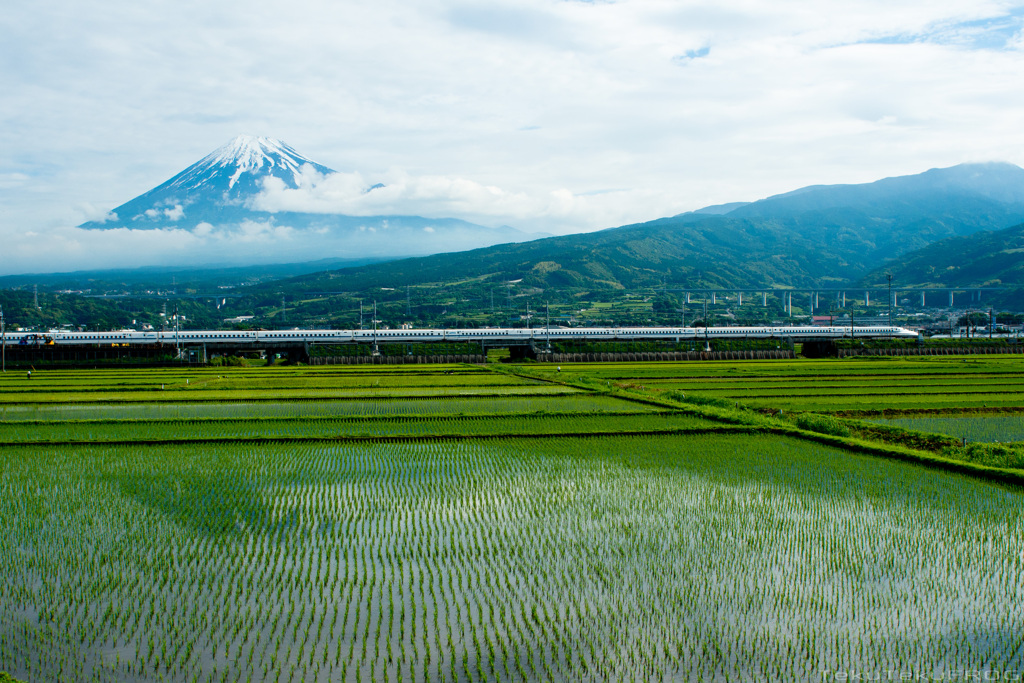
79,135,546,262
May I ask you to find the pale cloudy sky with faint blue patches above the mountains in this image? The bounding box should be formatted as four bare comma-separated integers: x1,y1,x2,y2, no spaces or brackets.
0,0,1024,272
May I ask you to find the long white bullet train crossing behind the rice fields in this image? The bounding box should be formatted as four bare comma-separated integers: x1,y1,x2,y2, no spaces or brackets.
3,326,918,347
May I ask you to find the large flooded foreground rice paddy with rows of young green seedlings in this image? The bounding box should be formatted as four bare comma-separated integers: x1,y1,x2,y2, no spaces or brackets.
0,435,1024,681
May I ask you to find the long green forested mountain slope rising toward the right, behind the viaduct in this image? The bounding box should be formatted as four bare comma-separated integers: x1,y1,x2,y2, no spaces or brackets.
268,163,1024,290
